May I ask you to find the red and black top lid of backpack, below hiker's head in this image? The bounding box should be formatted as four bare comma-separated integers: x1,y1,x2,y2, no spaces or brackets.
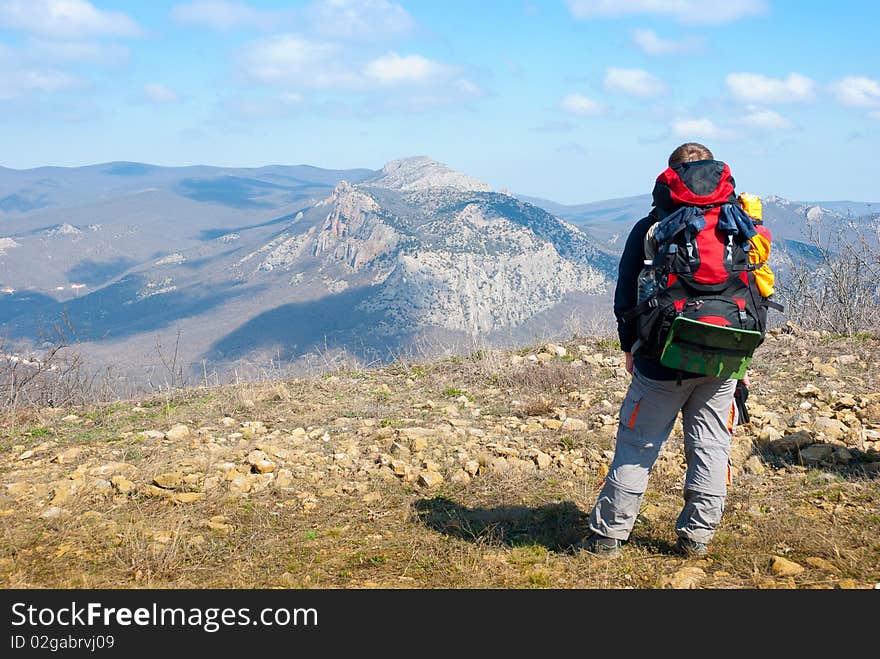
654,160,736,210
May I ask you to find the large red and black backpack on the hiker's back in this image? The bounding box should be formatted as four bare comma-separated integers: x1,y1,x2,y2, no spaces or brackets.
623,160,782,377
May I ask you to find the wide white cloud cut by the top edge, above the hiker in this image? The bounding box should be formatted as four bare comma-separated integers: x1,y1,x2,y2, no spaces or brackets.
565,0,767,25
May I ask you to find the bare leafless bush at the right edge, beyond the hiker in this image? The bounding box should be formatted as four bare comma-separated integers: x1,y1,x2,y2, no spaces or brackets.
779,214,880,337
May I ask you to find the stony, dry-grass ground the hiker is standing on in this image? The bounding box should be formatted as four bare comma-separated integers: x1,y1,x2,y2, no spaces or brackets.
0,326,880,589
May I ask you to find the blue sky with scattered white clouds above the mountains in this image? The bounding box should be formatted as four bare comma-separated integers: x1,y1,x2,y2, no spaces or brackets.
0,0,880,203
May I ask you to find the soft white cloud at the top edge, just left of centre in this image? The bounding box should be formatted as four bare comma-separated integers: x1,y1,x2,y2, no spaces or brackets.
304,0,415,41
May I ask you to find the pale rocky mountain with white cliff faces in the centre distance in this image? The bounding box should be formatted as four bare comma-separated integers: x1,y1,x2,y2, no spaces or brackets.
242,158,609,335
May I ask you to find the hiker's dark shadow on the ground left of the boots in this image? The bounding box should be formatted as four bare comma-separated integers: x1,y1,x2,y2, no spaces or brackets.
413,496,589,551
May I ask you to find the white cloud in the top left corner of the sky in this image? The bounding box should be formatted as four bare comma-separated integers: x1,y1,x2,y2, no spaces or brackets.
0,0,141,39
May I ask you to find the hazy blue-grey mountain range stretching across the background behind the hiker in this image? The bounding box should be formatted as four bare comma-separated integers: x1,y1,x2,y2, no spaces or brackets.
0,157,872,382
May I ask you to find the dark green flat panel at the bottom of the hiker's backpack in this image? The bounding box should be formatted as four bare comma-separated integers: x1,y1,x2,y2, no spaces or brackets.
660,316,761,380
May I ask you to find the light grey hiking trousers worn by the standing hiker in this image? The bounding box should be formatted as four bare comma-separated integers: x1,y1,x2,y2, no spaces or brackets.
590,370,736,544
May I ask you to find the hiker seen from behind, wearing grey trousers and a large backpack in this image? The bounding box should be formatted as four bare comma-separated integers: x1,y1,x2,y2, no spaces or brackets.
576,142,763,558
